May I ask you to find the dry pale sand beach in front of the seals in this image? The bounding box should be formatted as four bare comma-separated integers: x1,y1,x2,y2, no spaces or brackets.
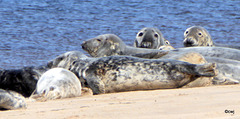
0,85,240,119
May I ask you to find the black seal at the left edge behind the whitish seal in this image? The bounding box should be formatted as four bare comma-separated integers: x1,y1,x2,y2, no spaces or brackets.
0,66,48,97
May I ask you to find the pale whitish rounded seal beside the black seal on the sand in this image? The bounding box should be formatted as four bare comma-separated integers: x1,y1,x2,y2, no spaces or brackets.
31,68,82,101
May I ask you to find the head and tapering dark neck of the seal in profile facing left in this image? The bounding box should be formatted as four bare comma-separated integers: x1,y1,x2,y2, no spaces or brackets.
82,34,168,57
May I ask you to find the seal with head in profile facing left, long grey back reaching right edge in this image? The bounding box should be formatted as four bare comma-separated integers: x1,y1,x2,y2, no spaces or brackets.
82,34,240,61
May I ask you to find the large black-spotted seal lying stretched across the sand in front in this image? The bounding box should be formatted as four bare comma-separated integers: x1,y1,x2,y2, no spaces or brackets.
49,52,216,94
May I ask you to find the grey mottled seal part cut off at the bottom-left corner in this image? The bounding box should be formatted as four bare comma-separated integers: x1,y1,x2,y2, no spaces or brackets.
0,89,27,110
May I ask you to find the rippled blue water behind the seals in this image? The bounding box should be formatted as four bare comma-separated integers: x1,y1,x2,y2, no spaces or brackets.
0,0,240,69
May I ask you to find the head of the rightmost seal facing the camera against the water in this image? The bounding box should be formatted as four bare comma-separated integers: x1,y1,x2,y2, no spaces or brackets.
183,26,214,47
